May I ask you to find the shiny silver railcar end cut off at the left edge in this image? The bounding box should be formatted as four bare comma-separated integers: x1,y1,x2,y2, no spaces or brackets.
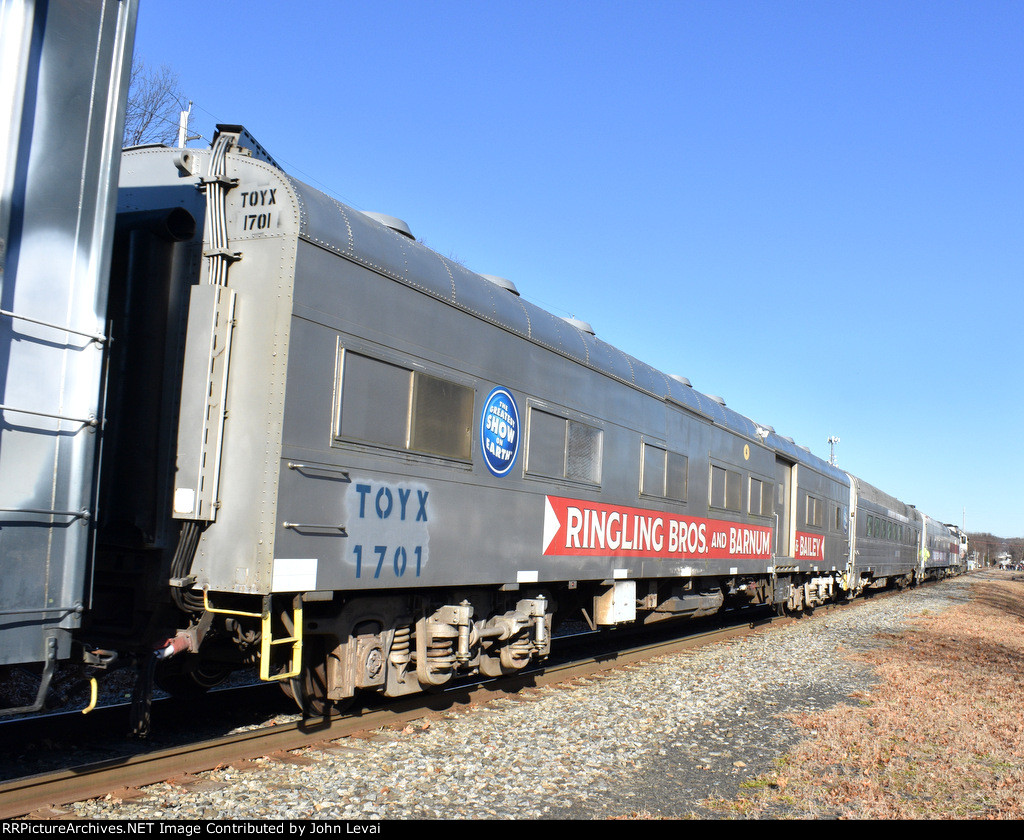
0,0,137,688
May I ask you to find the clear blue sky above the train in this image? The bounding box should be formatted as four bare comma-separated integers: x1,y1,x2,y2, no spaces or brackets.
136,0,1024,537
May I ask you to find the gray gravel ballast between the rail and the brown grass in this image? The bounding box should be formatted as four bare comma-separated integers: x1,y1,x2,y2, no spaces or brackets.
61,578,970,820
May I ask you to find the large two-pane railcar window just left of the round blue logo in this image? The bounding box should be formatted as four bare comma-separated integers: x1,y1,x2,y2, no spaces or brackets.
336,350,473,461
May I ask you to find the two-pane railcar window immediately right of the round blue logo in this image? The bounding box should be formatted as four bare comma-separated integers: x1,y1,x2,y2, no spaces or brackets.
526,408,603,485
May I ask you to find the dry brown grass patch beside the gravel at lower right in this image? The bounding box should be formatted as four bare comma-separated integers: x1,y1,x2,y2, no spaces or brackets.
705,575,1024,820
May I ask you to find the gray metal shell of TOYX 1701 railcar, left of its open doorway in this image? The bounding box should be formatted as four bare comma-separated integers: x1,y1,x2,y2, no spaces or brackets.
116,139,794,593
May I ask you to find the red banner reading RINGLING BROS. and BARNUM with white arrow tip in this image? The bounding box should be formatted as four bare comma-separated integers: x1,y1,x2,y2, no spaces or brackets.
544,496,774,560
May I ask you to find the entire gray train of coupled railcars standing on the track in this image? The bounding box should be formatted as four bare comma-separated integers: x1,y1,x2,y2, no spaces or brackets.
0,2,966,725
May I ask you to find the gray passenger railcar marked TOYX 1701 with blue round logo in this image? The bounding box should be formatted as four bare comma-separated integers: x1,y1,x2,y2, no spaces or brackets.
101,128,806,701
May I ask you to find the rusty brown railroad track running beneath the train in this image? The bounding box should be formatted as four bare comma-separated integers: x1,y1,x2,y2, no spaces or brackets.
0,599,888,818
